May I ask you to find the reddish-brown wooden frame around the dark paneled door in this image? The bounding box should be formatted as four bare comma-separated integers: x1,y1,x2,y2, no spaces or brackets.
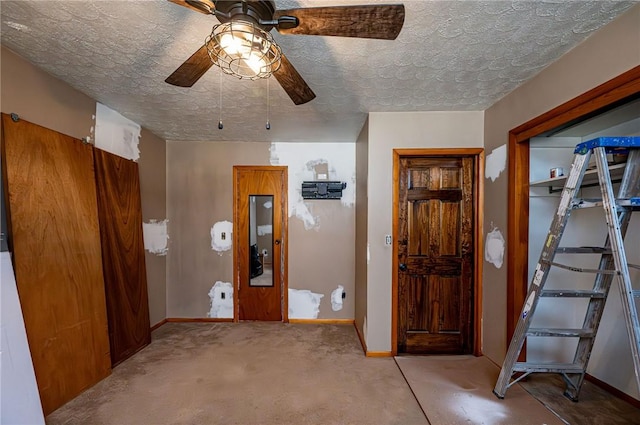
391,148,484,356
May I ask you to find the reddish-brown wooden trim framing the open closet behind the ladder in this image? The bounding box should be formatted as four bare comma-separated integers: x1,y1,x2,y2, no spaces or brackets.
507,66,640,341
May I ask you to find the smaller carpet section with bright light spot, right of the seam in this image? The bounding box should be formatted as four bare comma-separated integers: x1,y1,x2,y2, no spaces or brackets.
396,356,565,425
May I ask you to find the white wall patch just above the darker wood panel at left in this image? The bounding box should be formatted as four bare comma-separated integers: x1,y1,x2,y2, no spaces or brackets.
95,103,140,161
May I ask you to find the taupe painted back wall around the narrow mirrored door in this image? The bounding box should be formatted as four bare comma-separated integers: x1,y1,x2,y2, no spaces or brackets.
167,141,355,319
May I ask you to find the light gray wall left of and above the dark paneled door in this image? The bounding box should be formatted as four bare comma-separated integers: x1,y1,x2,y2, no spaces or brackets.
364,111,484,352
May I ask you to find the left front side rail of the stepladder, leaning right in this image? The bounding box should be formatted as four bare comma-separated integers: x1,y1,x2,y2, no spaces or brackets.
493,150,591,398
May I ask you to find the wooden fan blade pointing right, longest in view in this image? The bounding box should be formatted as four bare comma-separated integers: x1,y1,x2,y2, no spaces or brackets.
274,4,404,40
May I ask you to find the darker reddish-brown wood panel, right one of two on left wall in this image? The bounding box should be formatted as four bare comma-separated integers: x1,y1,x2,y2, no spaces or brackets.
94,149,151,366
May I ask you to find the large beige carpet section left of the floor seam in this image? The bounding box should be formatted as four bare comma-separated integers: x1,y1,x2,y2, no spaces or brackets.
46,323,427,425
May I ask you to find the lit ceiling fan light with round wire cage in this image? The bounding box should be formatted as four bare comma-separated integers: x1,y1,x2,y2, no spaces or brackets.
205,21,282,80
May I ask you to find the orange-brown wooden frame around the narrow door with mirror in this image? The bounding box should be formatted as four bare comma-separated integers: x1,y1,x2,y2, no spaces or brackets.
233,165,289,323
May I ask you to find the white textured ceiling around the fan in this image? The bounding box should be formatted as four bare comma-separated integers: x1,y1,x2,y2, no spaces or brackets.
0,0,637,141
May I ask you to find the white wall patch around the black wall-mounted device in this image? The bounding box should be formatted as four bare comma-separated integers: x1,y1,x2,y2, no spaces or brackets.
270,143,356,230
